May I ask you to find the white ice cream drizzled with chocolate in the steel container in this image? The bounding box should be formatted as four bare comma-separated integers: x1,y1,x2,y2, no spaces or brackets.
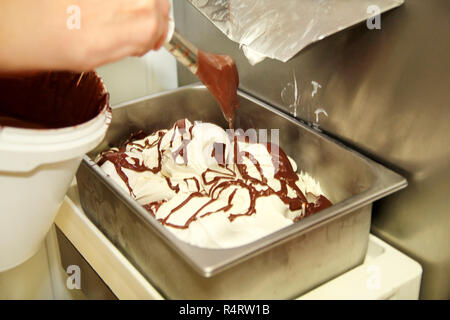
97,119,331,248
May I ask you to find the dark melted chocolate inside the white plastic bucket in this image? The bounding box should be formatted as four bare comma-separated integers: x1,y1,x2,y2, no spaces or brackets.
0,71,109,129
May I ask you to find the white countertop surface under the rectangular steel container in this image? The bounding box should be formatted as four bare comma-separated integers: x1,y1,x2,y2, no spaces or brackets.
55,185,422,299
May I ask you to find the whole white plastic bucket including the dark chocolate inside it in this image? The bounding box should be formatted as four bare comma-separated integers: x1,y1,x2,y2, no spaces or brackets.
0,72,111,272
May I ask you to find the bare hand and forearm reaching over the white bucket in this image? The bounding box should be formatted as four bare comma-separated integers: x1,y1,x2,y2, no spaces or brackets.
0,0,170,72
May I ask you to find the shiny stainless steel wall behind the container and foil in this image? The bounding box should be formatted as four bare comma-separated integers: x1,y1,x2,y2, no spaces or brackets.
174,0,450,299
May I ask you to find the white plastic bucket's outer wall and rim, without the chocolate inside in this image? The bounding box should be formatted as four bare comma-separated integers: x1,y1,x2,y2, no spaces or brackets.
0,71,111,272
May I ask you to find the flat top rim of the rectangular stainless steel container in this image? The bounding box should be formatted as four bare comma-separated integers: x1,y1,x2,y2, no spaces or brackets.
83,83,408,277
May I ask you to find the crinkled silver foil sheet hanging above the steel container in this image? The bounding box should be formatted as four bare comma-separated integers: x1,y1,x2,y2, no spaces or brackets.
189,0,404,64
